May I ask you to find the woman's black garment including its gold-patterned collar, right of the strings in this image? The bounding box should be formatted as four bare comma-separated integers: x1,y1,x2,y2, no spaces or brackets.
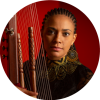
46,55,93,100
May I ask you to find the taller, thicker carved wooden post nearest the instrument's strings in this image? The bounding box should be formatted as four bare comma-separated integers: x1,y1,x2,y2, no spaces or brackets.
28,27,37,99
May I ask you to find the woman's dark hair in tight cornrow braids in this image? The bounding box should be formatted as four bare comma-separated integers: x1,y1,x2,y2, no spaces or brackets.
41,8,77,34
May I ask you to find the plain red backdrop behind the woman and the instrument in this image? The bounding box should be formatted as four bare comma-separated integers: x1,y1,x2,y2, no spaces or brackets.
0,0,100,79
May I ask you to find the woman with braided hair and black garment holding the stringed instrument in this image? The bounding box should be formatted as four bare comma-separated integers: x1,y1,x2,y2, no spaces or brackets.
13,8,93,100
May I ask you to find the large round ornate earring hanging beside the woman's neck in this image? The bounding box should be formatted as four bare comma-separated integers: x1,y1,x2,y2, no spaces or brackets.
67,45,78,62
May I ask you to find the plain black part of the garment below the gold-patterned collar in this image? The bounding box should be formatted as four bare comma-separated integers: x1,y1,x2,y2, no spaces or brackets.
50,65,93,100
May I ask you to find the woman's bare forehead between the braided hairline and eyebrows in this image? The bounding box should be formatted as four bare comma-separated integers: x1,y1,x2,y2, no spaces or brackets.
45,15,74,29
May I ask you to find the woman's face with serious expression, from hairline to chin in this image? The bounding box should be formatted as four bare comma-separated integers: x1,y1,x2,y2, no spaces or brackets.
42,15,77,60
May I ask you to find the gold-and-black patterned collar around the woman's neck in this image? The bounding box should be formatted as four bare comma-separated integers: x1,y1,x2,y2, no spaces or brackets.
46,55,81,82
